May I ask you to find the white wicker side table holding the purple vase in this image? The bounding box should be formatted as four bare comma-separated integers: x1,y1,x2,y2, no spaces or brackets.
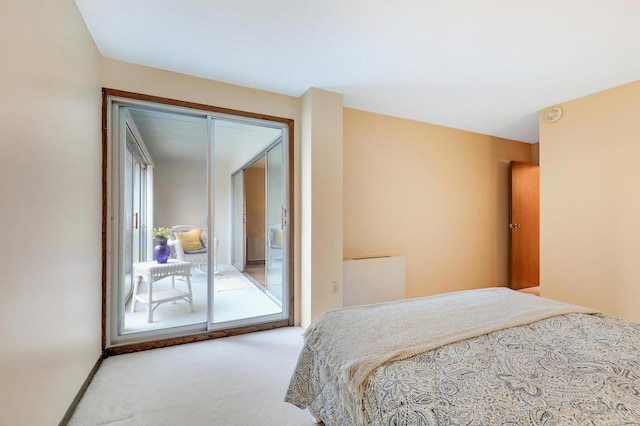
131,259,193,322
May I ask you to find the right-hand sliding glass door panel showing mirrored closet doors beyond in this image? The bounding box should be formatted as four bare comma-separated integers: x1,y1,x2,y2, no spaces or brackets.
211,118,289,329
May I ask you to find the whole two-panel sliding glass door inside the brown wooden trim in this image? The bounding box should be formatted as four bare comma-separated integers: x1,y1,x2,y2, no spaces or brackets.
107,95,289,345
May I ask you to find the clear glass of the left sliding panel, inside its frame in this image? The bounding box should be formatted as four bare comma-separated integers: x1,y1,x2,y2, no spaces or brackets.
120,108,208,334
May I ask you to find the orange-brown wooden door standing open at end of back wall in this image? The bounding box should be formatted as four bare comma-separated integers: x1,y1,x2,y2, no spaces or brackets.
509,161,540,290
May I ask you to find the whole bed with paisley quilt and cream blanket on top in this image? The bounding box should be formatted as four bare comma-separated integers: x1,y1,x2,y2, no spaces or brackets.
285,288,640,426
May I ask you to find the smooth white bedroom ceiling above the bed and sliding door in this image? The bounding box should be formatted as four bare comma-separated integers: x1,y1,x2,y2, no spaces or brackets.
76,0,640,142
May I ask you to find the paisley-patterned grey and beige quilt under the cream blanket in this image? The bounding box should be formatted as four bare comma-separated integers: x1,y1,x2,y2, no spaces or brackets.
285,314,640,426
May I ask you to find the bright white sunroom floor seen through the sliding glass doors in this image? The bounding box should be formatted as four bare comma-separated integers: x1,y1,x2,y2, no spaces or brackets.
123,265,282,334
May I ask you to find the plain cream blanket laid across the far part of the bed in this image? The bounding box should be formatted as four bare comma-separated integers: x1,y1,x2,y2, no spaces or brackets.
289,287,596,423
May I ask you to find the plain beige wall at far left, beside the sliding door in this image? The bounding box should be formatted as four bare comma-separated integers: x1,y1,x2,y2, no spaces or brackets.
0,0,102,425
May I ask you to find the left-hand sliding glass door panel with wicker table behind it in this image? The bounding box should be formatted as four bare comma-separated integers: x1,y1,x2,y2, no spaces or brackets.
108,100,210,344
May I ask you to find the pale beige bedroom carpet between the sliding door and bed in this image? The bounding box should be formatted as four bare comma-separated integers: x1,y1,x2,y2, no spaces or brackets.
69,327,314,426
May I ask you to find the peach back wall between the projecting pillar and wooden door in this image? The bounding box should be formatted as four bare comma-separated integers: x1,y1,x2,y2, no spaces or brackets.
344,108,531,297
